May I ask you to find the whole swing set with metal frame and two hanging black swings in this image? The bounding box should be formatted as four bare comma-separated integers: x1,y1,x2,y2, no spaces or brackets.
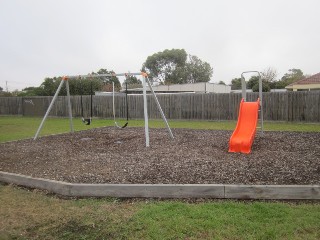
33,72,174,147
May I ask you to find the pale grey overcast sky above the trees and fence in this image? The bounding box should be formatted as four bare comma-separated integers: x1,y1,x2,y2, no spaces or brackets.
0,0,320,91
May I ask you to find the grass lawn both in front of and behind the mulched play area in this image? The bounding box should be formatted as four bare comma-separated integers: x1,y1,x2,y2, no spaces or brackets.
0,117,320,240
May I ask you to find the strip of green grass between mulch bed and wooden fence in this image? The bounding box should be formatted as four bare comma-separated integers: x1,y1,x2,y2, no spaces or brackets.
0,116,320,142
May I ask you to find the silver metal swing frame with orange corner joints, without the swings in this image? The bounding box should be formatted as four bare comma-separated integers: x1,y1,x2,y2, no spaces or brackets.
33,72,174,147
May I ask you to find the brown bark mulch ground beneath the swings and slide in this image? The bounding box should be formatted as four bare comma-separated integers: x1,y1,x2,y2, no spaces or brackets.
0,127,320,184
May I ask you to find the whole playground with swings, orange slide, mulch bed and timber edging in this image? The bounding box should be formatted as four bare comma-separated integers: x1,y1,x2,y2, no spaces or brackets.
0,71,320,199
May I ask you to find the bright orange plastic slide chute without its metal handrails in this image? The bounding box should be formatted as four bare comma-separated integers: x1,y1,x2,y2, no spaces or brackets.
229,99,260,153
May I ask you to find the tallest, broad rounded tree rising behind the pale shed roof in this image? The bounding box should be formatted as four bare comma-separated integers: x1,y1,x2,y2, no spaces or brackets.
142,49,213,84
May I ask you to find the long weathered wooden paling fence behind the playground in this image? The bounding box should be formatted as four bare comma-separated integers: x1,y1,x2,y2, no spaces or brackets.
0,91,320,122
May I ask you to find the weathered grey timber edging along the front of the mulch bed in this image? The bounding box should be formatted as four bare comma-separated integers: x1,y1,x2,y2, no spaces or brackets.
0,171,320,200
